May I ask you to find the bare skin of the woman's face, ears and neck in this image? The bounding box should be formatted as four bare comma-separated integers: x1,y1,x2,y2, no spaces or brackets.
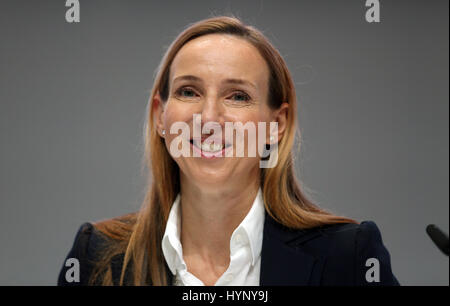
153,34,288,285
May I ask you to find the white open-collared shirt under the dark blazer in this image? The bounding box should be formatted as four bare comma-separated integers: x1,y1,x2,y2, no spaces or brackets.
162,188,265,286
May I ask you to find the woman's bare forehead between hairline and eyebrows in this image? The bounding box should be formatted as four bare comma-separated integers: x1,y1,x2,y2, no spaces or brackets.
170,34,269,87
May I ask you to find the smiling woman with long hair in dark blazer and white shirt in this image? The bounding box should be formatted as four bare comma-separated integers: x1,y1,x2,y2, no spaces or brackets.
58,17,398,285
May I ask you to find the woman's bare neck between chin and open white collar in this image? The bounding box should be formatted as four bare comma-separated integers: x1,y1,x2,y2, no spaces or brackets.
180,173,259,268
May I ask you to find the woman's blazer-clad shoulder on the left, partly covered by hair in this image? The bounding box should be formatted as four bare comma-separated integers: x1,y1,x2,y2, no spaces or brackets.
58,213,135,286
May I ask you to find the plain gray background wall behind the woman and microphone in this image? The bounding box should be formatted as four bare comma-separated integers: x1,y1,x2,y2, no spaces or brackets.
0,0,449,285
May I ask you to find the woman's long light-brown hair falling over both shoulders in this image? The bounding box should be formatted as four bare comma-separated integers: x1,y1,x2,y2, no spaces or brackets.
90,16,357,286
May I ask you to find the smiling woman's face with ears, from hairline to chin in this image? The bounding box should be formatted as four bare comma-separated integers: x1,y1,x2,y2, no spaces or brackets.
153,34,287,188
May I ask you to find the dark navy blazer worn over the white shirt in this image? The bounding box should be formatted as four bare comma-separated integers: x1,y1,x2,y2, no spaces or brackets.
58,213,400,286
